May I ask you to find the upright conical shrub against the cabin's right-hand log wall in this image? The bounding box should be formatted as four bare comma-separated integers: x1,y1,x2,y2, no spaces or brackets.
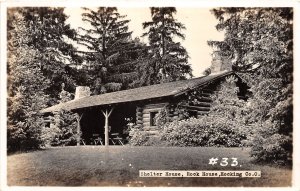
204,76,250,146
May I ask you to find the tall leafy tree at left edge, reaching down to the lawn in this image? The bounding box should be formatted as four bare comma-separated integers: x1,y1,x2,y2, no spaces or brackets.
7,12,50,151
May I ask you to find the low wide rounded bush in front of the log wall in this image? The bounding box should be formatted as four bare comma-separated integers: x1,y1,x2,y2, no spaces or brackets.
159,116,246,147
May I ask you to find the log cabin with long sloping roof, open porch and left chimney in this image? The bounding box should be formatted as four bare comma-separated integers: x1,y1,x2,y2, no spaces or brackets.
41,71,248,146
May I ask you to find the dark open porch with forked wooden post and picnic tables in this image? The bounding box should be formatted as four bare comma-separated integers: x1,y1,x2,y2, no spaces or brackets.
76,104,136,146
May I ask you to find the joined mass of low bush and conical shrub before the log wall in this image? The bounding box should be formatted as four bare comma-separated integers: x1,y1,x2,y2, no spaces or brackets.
160,77,249,147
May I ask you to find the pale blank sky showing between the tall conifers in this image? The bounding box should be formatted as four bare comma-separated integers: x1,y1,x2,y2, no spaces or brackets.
65,7,224,77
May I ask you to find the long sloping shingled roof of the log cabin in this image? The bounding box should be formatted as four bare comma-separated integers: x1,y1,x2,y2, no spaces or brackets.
41,71,233,113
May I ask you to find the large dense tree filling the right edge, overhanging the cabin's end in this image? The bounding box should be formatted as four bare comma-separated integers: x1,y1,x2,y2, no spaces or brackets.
209,8,293,162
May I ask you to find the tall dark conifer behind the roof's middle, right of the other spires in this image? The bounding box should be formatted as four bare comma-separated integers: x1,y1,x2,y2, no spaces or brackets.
139,7,192,85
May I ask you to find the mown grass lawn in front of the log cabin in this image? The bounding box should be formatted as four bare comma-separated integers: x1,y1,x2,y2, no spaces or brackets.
7,146,292,186
